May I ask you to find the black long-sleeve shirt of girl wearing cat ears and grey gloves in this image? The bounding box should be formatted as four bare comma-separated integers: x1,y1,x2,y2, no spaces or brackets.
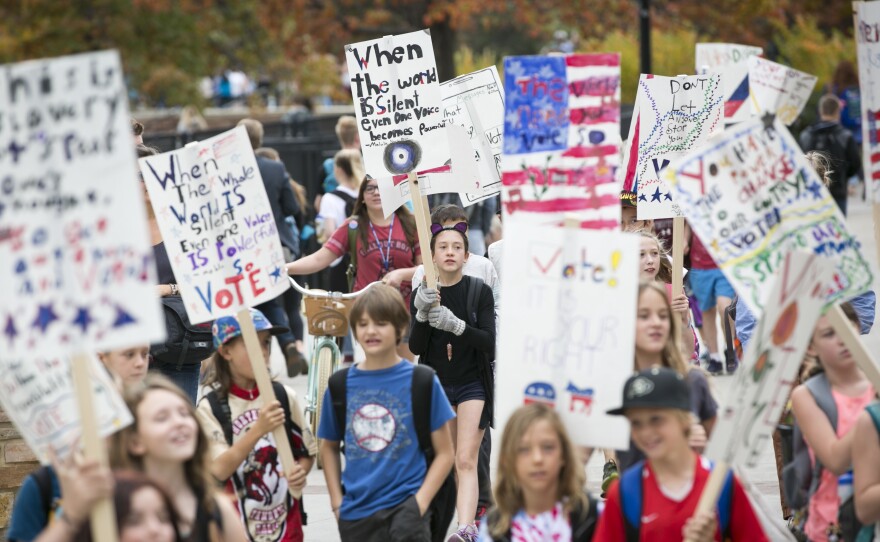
409,280,495,386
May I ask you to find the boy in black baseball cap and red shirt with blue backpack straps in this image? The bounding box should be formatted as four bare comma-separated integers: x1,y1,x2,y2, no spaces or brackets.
595,367,768,541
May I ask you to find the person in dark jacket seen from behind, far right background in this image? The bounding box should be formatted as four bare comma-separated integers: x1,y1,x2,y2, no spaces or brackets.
800,94,862,216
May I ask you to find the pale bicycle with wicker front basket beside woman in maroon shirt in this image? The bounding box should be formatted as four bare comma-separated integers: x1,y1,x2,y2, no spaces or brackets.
288,277,380,452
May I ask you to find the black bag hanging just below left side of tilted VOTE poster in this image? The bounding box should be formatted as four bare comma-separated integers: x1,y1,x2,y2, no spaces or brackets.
150,295,214,369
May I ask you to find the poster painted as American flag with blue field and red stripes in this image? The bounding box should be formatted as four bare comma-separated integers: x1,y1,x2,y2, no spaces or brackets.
501,54,620,229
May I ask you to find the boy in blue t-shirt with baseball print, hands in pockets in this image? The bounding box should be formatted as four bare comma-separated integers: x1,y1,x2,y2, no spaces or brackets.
318,285,455,542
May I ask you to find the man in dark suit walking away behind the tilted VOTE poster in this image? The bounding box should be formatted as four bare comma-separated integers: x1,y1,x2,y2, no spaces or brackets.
238,119,309,376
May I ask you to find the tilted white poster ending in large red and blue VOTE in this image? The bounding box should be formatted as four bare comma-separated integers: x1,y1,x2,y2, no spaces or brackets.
140,126,290,324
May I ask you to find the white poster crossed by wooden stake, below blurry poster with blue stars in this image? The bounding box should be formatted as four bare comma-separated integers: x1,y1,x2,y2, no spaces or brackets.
0,354,133,464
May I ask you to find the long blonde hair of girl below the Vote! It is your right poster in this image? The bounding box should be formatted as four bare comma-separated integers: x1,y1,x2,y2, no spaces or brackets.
489,404,588,539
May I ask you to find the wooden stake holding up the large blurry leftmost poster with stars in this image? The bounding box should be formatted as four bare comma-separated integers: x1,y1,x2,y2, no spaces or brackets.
70,354,118,542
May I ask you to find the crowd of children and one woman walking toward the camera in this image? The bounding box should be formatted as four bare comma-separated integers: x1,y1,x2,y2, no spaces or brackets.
8,115,880,542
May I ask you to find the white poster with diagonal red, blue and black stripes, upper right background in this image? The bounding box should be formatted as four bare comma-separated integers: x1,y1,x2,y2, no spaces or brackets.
696,43,764,124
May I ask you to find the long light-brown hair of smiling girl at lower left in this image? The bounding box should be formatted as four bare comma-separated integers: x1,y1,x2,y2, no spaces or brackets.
110,373,216,511
